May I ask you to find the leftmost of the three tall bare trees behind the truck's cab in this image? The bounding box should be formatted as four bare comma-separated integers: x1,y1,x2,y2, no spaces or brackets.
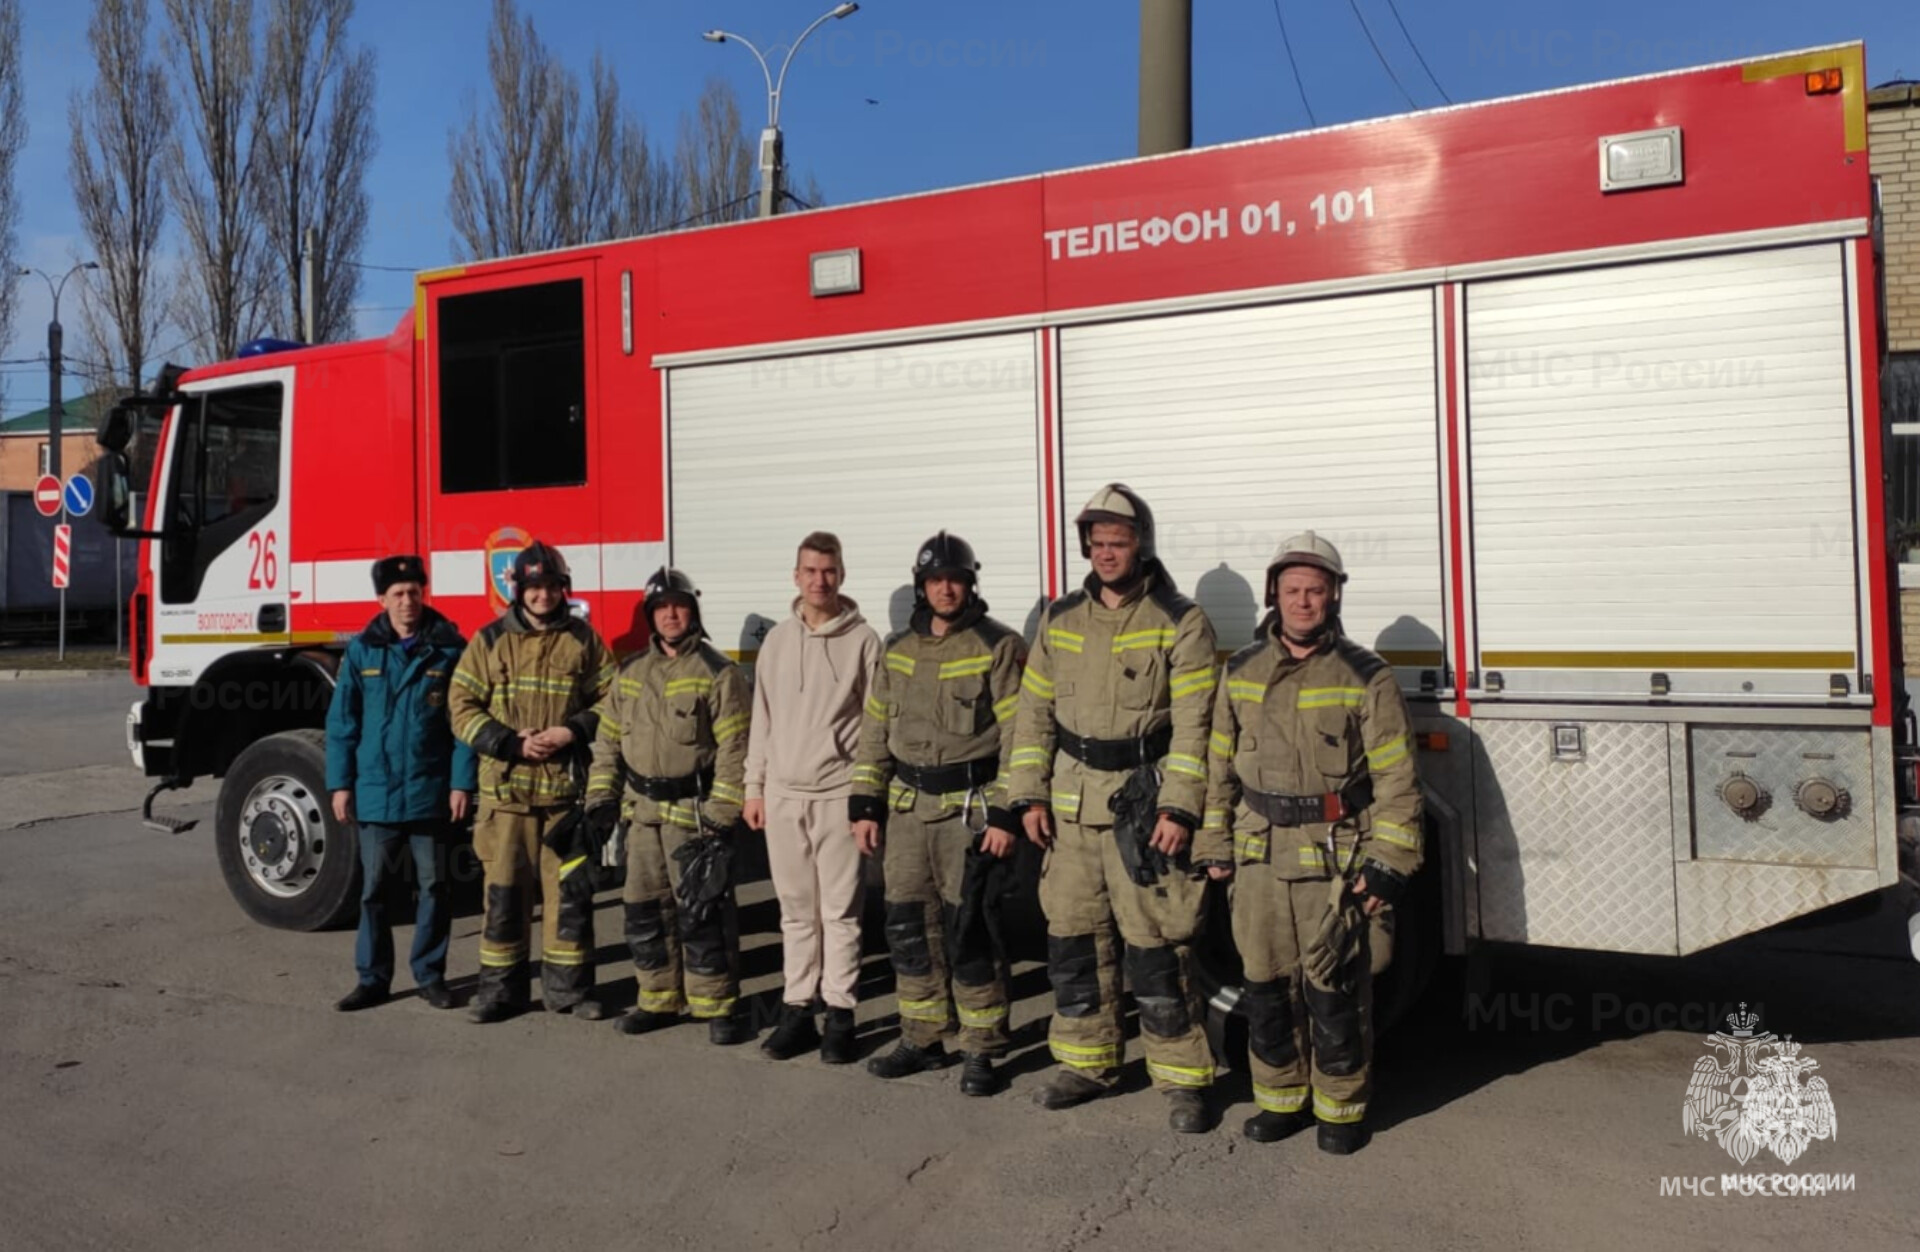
67,0,173,392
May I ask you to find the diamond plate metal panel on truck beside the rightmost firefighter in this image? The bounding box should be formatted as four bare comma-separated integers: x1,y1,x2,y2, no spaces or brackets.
1475,720,1678,954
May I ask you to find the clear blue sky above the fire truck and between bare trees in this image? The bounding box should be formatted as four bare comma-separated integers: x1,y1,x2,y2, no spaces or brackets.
0,0,1920,415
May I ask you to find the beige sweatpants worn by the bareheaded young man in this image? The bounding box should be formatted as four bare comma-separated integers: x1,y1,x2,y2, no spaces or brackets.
766,791,864,1008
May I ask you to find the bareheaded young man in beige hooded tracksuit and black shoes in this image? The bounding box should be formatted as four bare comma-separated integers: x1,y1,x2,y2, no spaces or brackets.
741,532,881,1064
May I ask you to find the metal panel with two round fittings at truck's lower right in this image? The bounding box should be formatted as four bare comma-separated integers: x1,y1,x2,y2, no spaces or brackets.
1690,726,1874,870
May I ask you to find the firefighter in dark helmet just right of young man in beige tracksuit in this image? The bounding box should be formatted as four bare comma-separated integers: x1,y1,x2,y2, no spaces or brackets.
847,530,1027,1096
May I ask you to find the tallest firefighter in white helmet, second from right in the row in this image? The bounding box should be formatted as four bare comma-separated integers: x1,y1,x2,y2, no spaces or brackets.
1010,484,1215,1133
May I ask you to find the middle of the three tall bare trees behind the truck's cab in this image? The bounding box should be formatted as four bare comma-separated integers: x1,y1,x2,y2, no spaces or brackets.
165,0,267,357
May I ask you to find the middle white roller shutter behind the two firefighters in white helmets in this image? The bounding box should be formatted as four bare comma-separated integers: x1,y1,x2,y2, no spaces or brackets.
1060,290,1446,684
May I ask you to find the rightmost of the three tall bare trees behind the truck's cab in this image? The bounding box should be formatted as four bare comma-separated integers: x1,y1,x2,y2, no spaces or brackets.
253,0,376,344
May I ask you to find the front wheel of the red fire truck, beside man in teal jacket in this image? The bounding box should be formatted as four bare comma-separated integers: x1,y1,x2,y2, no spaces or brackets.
213,730,359,931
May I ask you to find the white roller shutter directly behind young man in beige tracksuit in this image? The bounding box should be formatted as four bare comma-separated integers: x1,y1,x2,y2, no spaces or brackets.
668,334,1043,653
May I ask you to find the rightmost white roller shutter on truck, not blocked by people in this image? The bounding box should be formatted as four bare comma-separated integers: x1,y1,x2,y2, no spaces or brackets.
1467,246,1859,695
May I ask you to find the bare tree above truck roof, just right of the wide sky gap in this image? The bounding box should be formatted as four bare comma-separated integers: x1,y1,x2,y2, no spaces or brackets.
447,0,578,259
